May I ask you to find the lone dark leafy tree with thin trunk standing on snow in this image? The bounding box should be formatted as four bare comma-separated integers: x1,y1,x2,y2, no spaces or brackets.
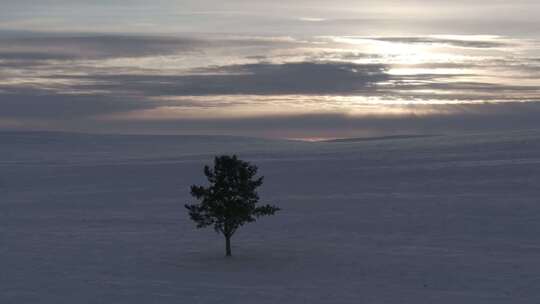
185,155,280,256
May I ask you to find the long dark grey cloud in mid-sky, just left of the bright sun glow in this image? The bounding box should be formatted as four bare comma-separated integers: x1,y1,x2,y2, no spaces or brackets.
47,62,389,96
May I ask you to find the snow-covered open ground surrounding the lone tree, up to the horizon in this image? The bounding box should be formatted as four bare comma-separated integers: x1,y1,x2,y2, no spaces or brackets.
0,131,540,304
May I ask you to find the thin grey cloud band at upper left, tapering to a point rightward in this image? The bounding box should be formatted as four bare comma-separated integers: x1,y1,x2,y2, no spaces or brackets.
0,31,305,64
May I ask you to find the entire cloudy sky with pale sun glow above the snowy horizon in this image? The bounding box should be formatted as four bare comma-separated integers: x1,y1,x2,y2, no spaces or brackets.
0,0,540,139
